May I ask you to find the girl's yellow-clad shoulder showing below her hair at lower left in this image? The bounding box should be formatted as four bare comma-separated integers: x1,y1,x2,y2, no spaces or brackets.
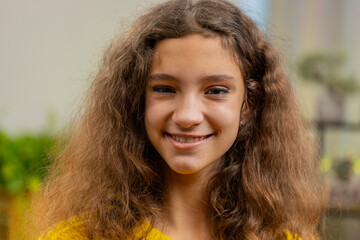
39,217,85,240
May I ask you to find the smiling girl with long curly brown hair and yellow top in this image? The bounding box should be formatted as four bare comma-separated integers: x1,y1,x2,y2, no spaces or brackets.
36,0,323,240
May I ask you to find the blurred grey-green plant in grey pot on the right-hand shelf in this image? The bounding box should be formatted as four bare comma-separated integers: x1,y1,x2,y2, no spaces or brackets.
297,52,360,123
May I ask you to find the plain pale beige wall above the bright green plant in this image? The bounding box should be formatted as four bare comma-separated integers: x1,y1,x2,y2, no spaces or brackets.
0,0,165,134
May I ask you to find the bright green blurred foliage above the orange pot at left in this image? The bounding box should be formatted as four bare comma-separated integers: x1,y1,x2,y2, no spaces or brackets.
0,132,54,194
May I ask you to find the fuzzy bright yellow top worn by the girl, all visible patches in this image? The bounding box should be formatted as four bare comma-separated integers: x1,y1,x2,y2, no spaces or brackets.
39,217,302,240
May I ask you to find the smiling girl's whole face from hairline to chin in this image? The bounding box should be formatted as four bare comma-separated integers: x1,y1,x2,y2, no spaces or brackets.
145,34,244,174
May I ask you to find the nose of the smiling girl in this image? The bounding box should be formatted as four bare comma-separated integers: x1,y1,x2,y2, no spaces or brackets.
172,96,204,128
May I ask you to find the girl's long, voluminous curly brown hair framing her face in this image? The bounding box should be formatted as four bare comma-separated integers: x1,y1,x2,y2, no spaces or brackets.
35,0,324,240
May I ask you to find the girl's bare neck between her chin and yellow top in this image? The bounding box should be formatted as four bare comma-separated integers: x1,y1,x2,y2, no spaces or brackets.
156,166,215,239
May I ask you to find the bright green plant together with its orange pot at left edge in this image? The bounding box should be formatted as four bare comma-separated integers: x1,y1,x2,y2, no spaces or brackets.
0,131,54,239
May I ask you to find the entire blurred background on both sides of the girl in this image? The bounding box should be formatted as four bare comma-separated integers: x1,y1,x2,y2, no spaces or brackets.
0,0,360,240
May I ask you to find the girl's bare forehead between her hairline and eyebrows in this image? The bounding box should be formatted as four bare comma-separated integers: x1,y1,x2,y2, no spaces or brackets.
150,34,240,79
